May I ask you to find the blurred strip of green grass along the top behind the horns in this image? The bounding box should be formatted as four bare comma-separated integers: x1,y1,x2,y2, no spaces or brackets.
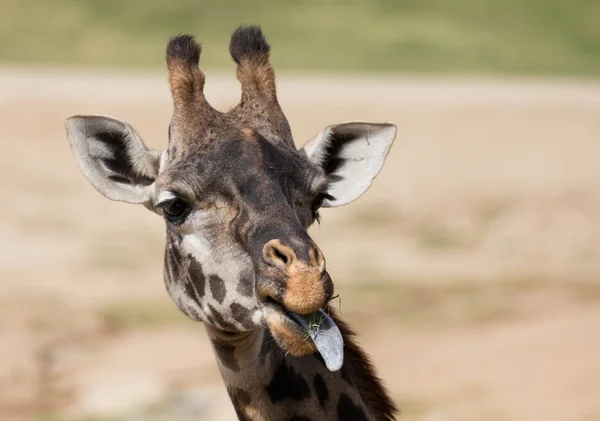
0,0,600,76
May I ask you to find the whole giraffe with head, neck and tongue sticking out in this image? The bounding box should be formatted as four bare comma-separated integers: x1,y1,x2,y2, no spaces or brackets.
65,26,397,421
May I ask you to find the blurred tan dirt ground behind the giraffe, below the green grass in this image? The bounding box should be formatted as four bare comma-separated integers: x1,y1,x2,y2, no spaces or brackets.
0,68,600,421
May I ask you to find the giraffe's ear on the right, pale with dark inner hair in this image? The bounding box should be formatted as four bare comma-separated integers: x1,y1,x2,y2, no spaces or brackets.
302,122,396,207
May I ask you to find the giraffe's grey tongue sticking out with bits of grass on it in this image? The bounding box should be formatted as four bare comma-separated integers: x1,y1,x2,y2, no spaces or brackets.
289,310,344,371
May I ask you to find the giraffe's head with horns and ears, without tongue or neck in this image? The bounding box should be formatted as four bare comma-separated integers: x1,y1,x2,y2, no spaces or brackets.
66,27,396,368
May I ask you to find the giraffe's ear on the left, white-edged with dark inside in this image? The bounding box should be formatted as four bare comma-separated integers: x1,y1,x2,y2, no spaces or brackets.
65,116,162,203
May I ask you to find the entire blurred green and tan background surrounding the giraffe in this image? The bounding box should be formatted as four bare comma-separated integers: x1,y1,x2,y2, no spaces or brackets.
0,0,600,421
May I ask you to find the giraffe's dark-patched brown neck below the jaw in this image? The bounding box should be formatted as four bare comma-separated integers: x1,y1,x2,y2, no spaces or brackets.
207,312,396,421
